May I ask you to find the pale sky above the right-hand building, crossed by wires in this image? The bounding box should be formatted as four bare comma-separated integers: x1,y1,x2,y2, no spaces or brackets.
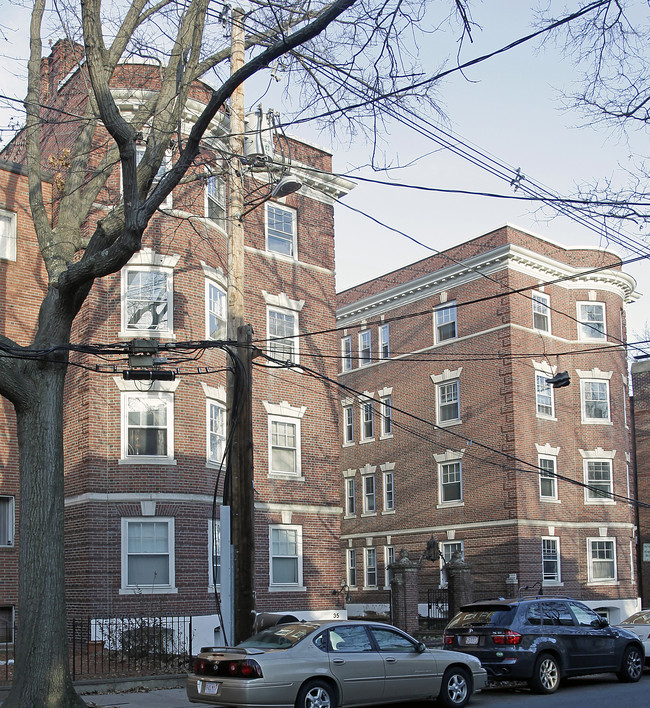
0,0,650,339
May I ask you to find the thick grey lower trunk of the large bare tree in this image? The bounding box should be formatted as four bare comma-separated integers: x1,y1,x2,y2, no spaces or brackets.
3,361,86,708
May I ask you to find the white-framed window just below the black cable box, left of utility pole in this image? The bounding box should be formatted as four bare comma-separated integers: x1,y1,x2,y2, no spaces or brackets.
122,391,174,464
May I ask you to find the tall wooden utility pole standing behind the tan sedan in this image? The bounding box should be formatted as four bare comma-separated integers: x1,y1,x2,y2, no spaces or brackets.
226,8,255,644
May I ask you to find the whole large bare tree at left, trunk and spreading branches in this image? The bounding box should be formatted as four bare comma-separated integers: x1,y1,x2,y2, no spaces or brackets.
0,0,476,708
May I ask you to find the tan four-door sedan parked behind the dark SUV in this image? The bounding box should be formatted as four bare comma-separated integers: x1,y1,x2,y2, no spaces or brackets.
186,620,487,708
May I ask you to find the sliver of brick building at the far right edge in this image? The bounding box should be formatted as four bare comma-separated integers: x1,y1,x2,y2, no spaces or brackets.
632,359,650,608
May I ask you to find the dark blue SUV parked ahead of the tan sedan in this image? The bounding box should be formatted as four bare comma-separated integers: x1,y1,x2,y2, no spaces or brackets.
444,597,644,693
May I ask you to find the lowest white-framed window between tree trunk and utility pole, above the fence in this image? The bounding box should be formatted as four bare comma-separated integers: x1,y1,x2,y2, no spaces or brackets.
122,517,174,592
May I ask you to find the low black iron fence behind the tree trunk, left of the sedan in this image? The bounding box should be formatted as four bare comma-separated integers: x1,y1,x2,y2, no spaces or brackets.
0,616,192,683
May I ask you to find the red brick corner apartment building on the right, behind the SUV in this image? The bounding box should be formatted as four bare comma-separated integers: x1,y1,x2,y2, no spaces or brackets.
337,226,639,621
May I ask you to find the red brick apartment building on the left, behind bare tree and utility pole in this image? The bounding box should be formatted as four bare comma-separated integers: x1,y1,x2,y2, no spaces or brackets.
0,42,353,644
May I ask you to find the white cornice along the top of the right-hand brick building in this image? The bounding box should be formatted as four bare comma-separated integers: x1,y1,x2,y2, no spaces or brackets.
336,243,640,325
